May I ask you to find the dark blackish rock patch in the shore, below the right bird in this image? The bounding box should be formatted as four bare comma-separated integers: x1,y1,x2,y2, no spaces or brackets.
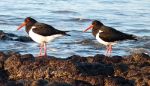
77,63,114,76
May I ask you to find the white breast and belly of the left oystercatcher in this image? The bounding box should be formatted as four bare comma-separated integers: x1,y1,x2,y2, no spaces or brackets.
29,26,63,43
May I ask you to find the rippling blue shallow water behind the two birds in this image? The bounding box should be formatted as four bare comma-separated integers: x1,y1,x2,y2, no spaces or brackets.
0,0,150,58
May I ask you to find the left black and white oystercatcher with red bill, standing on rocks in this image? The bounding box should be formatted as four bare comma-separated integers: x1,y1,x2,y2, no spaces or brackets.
17,17,70,56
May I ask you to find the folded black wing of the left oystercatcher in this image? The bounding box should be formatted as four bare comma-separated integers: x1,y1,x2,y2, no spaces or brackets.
33,23,66,36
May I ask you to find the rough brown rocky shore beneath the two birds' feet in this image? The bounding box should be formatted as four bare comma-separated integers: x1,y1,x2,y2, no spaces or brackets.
0,52,150,86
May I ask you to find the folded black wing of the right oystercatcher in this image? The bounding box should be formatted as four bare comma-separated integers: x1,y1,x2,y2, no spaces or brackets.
99,26,133,42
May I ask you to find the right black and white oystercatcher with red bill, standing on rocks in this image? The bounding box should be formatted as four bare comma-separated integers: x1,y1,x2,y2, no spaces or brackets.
84,20,137,56
